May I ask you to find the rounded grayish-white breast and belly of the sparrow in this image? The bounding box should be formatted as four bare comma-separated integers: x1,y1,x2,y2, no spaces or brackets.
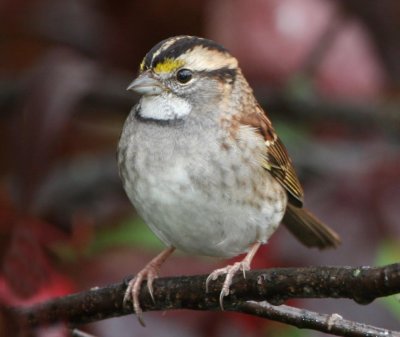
118,109,286,256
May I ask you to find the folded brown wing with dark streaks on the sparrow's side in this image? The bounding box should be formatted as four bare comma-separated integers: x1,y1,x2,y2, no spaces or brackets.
240,106,303,207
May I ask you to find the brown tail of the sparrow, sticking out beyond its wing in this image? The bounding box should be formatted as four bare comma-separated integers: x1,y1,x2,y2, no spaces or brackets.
283,204,340,249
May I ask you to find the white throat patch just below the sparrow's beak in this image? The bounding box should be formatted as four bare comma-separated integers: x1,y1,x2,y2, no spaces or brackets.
139,94,192,120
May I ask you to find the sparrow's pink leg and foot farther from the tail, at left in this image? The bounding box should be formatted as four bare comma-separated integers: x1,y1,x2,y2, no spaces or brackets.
123,247,175,326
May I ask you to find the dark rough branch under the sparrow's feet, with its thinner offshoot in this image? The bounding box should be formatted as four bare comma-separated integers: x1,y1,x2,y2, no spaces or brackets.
13,263,400,337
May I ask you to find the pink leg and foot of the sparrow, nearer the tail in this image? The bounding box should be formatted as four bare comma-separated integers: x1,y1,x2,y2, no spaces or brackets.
206,242,261,310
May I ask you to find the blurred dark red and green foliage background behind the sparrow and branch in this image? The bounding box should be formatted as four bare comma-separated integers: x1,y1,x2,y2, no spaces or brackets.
0,0,400,337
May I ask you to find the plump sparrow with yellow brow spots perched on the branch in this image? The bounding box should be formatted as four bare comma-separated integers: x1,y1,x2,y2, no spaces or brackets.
117,35,340,324
